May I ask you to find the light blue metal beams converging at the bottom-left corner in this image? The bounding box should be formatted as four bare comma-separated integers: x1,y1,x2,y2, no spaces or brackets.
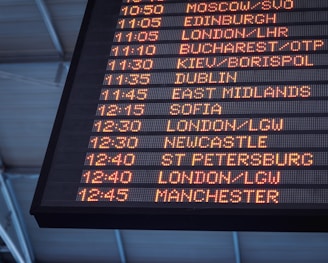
0,171,34,263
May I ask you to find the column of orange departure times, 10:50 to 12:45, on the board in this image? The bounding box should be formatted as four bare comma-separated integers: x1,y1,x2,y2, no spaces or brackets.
77,0,164,202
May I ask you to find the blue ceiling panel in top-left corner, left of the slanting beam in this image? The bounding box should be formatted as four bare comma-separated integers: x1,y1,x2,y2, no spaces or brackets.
0,0,54,61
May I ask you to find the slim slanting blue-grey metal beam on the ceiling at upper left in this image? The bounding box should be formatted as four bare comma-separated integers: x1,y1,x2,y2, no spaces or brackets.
35,0,65,59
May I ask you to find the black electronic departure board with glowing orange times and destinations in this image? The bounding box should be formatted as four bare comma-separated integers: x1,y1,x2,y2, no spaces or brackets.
31,0,328,231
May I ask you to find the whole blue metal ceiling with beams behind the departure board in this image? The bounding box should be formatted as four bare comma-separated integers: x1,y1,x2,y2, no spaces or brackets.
0,0,328,263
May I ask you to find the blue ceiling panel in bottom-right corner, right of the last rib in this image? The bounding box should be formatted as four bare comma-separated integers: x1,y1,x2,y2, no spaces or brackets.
239,232,328,263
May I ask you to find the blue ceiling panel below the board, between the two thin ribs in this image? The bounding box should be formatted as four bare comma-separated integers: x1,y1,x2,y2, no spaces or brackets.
122,231,235,263
